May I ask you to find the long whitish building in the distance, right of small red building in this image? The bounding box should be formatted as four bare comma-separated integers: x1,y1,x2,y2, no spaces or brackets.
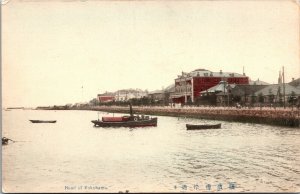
115,89,148,102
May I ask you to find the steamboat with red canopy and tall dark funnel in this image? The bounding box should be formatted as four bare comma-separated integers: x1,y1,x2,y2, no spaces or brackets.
91,105,157,127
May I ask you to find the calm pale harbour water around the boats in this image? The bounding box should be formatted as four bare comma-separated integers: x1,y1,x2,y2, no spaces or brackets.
2,110,300,192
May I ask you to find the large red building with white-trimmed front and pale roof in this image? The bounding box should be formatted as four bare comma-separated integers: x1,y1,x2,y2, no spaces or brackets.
171,69,249,103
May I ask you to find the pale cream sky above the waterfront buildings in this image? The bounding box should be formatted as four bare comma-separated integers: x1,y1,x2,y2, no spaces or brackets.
1,0,300,107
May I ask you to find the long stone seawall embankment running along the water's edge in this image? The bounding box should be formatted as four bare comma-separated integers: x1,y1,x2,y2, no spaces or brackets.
37,106,300,128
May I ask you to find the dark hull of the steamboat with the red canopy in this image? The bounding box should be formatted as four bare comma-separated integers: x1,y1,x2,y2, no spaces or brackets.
91,118,157,128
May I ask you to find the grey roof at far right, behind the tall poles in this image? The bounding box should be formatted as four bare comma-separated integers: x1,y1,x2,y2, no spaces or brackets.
255,84,300,96
